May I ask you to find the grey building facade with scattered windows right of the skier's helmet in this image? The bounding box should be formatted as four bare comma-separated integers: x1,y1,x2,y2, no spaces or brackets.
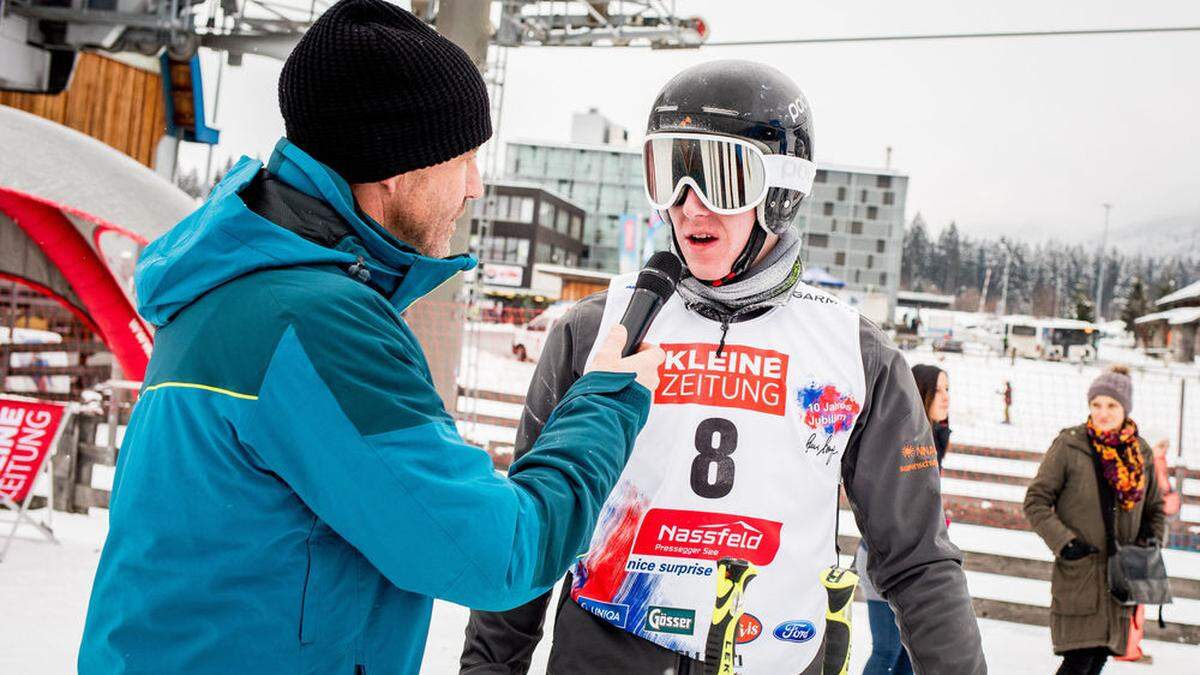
799,163,908,316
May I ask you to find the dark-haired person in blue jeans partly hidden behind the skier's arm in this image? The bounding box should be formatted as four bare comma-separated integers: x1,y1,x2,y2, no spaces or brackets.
856,364,950,675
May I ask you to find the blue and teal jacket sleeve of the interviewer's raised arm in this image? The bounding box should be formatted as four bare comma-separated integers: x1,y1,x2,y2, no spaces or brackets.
239,285,650,609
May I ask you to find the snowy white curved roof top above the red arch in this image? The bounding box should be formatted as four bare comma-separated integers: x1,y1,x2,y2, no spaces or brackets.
0,106,197,239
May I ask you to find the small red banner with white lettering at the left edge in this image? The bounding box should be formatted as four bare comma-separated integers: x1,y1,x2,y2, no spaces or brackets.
0,398,66,503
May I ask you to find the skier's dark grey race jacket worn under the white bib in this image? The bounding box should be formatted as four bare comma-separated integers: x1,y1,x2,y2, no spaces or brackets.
460,293,988,675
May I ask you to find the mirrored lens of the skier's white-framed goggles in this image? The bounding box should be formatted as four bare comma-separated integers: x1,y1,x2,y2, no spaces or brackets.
642,137,767,211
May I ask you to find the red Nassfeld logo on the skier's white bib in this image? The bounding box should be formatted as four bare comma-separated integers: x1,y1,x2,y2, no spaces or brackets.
632,508,784,567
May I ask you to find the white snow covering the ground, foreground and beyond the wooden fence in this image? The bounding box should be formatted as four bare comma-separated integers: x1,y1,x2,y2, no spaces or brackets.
0,328,1200,675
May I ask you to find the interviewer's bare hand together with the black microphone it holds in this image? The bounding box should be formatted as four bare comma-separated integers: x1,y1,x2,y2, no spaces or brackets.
588,251,682,392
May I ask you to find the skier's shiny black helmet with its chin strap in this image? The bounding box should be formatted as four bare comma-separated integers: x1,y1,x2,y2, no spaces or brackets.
646,59,812,283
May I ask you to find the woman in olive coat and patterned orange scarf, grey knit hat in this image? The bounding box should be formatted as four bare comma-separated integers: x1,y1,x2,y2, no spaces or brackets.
1025,366,1166,675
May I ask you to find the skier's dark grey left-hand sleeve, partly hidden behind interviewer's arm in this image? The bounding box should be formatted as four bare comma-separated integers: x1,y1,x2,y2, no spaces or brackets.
460,293,605,675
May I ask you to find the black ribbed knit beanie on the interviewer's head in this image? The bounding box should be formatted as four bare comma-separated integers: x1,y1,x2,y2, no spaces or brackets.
280,0,492,183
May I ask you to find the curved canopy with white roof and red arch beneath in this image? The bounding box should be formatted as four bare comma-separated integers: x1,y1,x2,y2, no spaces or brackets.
0,106,196,380
